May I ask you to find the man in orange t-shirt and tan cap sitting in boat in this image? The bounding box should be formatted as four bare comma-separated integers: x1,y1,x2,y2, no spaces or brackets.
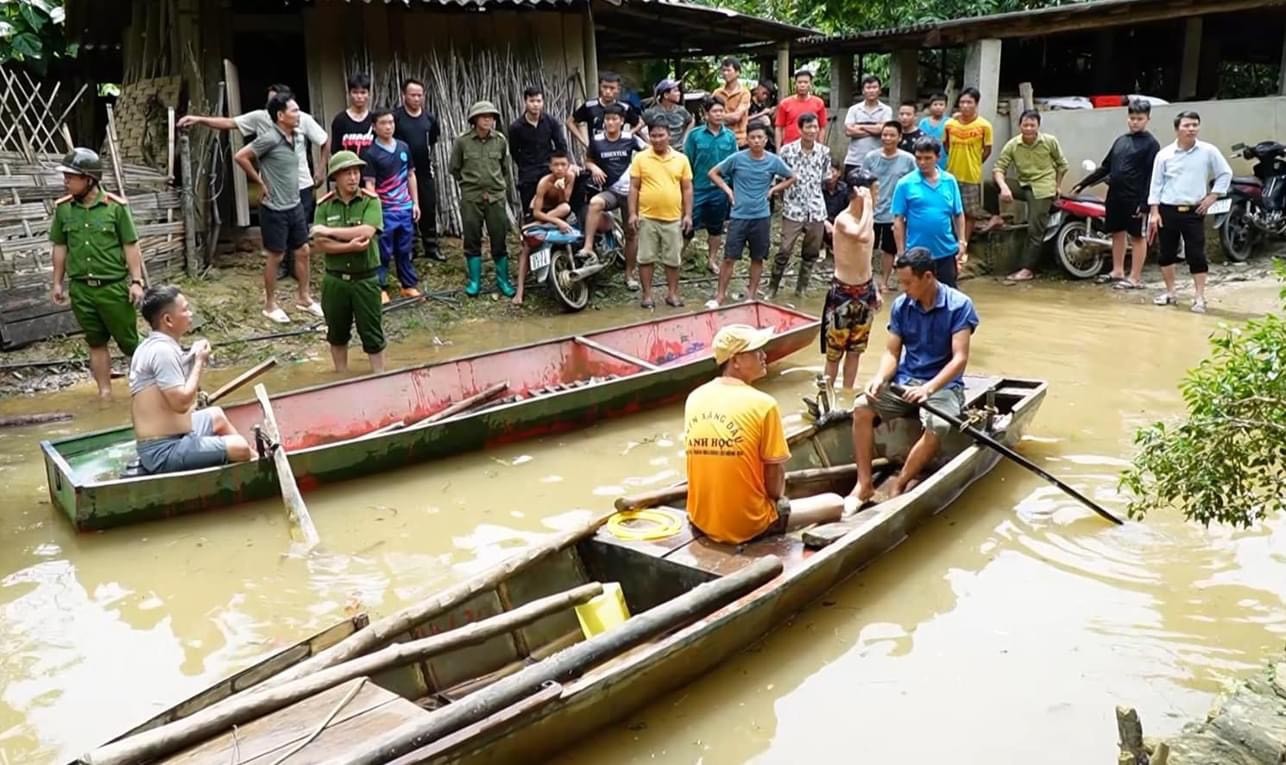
683,324,844,544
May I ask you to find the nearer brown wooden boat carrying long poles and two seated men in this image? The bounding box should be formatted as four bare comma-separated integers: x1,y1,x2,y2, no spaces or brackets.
84,378,1046,765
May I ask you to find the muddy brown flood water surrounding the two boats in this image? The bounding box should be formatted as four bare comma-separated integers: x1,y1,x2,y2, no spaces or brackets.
0,283,1286,764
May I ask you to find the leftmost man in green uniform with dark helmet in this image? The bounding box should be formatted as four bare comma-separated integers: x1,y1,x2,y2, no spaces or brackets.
49,148,143,399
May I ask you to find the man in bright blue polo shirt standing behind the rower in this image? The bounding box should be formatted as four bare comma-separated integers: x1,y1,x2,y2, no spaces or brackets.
892,138,968,287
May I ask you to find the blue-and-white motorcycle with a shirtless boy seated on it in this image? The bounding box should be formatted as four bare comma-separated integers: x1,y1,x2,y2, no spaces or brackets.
522,215,625,311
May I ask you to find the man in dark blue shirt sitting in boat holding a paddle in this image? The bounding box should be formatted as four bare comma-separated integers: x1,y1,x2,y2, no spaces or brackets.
850,247,979,503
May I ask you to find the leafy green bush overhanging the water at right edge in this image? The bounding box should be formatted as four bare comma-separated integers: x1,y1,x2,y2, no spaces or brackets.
1121,265,1286,526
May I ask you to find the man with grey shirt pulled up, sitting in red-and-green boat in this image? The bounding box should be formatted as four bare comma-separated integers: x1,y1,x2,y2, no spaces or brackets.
130,287,253,474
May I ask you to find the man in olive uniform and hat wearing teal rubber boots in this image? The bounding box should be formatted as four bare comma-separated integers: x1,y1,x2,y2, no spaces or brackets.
450,102,514,297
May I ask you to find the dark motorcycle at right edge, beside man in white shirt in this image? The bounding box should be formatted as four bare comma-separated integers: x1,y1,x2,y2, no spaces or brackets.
1208,140,1286,262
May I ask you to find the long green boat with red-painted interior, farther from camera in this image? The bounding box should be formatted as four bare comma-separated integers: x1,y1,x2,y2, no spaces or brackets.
41,302,818,530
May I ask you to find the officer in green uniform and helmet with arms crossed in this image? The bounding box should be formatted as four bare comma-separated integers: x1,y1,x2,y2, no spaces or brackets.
312,152,387,373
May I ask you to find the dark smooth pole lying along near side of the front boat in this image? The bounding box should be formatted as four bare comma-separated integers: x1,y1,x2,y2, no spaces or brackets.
347,555,782,765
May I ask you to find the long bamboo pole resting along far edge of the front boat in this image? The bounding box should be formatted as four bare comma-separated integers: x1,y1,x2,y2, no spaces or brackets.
264,513,611,687
